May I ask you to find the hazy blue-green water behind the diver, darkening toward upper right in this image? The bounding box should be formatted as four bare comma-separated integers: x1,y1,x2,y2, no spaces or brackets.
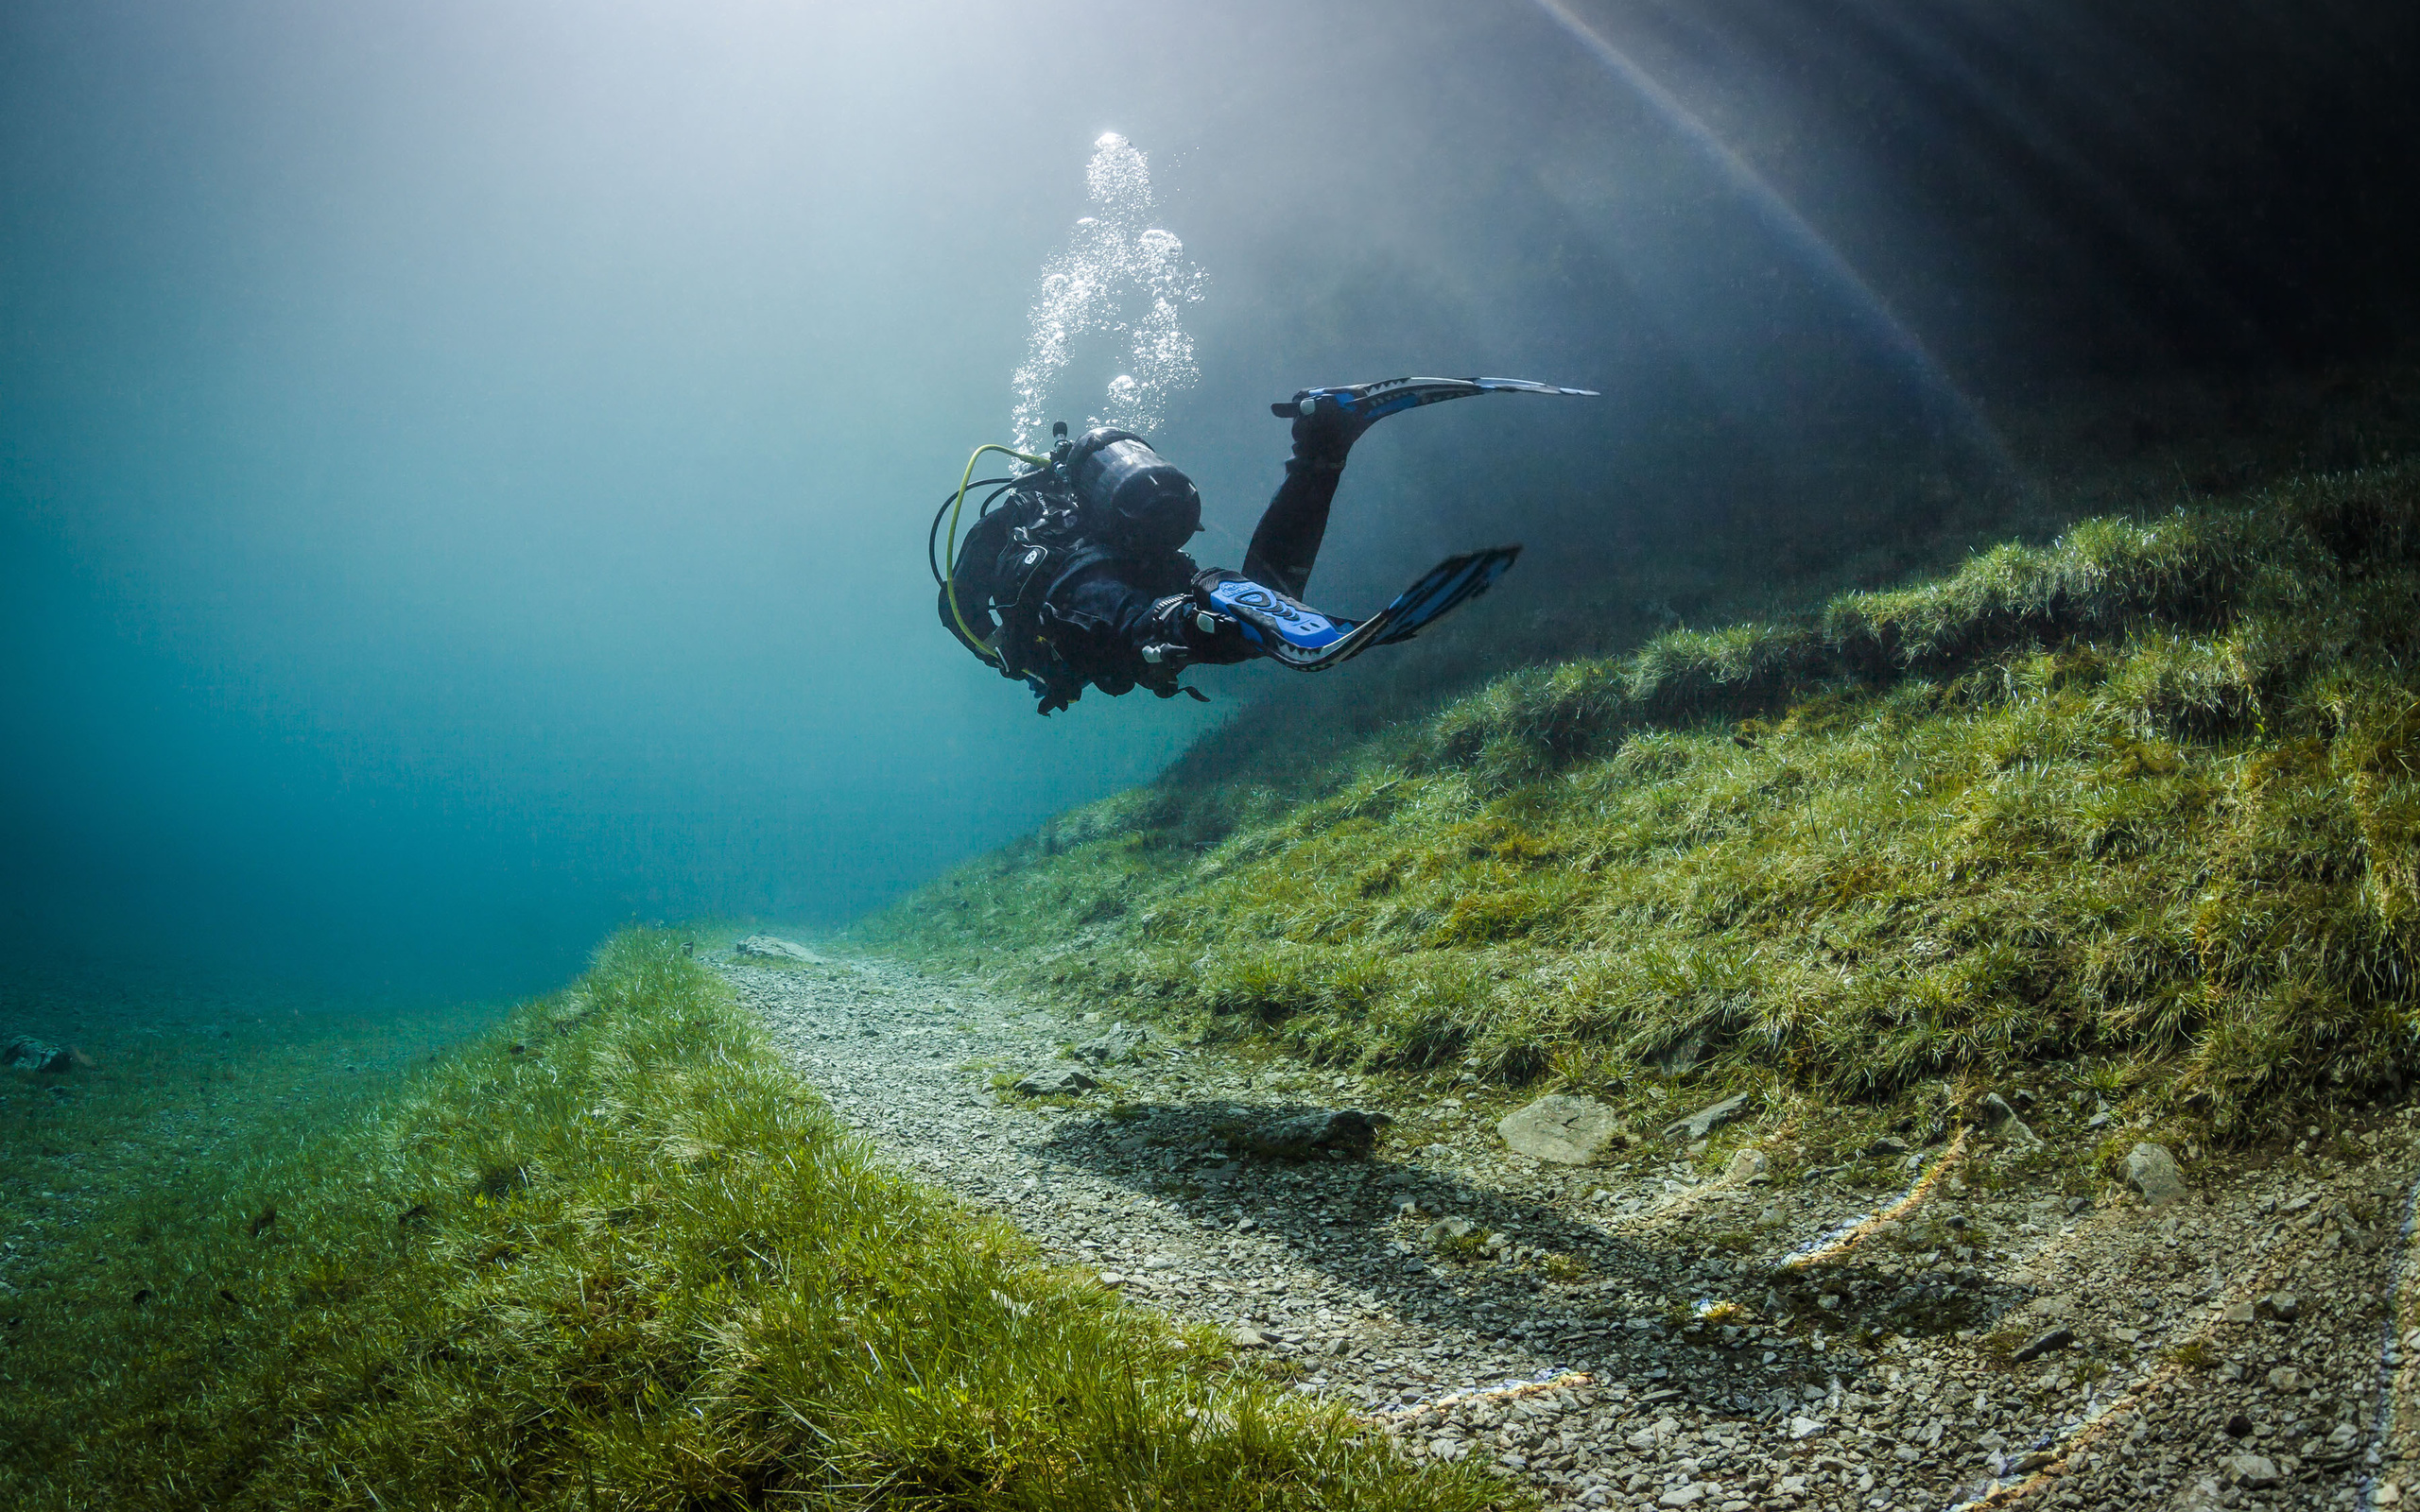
0,0,2420,1005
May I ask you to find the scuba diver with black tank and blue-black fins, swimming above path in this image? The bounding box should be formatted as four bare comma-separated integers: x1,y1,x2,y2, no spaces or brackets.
925,377,1595,713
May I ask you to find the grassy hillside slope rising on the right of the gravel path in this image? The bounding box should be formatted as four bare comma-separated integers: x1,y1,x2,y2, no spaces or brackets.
859,465,2420,1130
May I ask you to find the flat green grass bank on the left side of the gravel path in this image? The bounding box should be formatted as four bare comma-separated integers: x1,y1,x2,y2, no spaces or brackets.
0,932,1503,1509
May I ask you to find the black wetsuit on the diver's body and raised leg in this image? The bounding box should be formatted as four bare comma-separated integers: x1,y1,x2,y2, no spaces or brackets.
942,419,1367,713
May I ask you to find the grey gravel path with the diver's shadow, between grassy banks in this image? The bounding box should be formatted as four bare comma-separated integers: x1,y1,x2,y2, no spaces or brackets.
721,958,2420,1512
